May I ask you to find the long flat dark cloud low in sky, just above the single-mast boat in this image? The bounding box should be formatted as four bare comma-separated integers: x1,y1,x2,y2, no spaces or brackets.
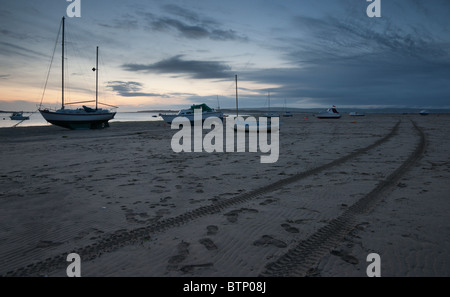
122,55,233,79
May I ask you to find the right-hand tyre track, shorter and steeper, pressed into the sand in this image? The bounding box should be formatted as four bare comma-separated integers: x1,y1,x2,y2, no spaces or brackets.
260,121,427,277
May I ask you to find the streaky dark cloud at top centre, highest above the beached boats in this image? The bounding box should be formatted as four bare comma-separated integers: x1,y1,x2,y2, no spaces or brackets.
144,5,248,41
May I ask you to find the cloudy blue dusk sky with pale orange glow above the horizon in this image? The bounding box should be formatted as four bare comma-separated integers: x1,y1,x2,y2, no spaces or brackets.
0,0,450,111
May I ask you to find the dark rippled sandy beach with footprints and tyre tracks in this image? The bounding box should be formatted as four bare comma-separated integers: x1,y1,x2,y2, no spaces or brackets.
0,114,450,277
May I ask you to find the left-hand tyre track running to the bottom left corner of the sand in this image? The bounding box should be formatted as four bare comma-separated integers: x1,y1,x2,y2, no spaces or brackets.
0,120,401,277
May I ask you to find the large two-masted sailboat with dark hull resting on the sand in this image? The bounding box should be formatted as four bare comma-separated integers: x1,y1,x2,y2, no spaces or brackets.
39,17,117,130
